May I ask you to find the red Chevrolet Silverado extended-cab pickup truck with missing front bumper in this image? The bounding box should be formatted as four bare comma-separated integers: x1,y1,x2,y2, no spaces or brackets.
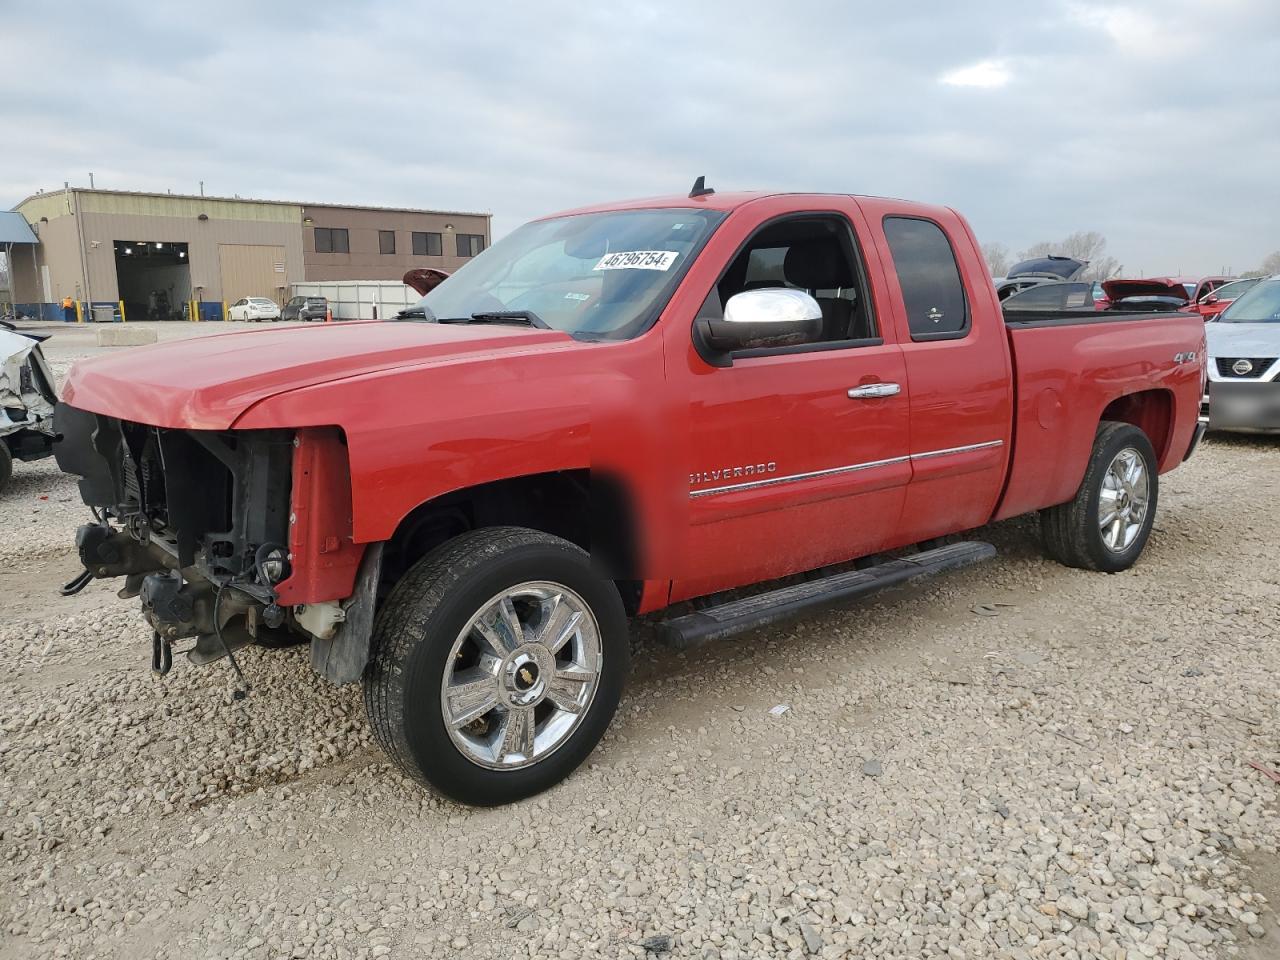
55,187,1204,804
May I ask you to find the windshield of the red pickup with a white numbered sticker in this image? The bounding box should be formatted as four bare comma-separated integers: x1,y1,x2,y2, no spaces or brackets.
401,209,724,339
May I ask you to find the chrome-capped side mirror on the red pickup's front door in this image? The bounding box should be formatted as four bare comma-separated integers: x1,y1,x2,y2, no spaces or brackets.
694,287,822,366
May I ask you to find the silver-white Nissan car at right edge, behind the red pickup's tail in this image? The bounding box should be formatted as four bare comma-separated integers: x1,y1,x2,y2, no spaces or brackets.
1201,276,1280,433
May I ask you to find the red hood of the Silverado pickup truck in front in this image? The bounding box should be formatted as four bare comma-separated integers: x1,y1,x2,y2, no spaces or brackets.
63,323,576,430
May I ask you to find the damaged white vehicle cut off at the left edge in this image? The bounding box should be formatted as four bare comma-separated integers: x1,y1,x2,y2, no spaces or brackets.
0,323,58,490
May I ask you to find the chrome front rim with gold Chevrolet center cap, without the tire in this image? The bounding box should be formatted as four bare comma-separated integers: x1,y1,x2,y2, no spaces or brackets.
440,581,602,769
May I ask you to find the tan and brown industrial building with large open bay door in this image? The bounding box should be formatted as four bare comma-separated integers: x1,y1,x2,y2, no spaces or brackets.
10,187,490,320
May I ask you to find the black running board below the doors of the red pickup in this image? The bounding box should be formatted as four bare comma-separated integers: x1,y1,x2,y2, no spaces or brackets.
659,540,996,650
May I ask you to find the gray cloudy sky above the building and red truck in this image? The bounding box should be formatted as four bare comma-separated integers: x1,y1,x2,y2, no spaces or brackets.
0,0,1280,275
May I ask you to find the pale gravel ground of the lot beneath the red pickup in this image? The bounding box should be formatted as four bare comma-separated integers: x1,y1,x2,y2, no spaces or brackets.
0,328,1280,960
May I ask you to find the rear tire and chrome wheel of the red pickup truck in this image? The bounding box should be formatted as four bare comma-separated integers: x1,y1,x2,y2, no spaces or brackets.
1041,420,1160,573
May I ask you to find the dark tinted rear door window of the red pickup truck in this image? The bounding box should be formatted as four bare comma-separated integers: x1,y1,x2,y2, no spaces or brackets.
884,216,969,340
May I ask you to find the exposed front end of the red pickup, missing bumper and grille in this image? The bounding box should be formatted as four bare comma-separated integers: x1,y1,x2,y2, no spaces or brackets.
54,403,380,682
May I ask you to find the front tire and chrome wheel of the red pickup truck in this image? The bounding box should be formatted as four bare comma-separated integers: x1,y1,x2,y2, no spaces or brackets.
365,527,630,806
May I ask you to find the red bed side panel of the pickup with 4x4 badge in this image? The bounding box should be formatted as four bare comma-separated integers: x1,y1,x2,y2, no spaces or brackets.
996,314,1204,520
